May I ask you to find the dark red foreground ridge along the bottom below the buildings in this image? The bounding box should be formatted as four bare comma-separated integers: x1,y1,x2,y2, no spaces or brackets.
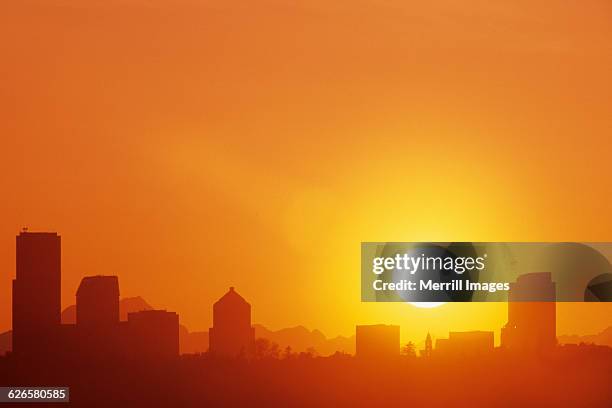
0,345,612,408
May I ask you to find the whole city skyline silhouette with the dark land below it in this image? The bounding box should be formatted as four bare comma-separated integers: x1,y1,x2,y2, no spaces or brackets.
0,231,612,407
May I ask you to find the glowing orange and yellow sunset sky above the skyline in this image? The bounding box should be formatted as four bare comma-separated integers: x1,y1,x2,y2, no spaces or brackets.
0,0,612,339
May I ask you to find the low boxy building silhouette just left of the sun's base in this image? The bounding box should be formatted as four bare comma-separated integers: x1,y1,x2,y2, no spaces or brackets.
355,324,400,359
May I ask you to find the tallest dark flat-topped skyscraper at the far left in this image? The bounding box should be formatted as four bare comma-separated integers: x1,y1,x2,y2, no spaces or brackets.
13,230,61,355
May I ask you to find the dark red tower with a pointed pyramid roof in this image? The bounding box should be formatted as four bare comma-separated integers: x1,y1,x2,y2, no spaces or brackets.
208,286,255,357
